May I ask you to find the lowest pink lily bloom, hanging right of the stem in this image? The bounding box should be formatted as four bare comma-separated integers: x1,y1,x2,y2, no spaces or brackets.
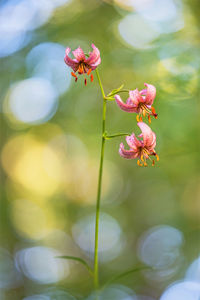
119,122,159,166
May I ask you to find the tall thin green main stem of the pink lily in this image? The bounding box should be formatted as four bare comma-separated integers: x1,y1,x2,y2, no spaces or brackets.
94,69,106,290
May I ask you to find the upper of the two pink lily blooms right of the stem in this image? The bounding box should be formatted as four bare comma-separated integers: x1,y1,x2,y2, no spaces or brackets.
115,83,157,123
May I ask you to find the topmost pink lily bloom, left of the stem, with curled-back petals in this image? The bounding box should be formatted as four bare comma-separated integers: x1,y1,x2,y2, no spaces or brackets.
64,44,101,85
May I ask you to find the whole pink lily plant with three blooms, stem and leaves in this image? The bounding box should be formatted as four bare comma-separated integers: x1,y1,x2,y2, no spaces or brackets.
60,44,159,299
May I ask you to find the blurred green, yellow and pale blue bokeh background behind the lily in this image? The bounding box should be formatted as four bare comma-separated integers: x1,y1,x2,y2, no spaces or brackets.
0,0,200,300
